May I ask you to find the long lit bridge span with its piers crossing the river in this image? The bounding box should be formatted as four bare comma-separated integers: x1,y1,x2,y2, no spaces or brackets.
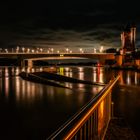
0,52,115,67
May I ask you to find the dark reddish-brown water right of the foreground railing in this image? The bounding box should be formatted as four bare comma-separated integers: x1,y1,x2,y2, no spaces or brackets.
112,71,140,139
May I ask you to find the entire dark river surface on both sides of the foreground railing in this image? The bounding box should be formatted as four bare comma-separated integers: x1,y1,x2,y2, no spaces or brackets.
0,66,140,140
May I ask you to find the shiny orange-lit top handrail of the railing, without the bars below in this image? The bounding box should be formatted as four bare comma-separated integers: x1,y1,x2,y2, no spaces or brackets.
47,75,120,140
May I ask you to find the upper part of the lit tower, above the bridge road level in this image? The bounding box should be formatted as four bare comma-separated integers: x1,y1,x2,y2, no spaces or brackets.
121,24,136,54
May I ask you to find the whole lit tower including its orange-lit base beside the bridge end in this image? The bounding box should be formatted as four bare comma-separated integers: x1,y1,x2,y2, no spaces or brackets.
116,24,136,66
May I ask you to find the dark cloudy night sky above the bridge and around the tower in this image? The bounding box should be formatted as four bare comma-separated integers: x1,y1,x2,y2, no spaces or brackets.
0,0,140,49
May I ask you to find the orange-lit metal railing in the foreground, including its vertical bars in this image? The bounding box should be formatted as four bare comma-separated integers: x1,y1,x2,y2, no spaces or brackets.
47,76,120,140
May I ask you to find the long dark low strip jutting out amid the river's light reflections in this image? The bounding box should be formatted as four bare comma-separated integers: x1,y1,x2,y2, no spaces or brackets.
19,72,105,88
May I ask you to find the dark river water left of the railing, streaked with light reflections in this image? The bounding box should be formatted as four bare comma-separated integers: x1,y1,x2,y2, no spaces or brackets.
0,67,110,140
